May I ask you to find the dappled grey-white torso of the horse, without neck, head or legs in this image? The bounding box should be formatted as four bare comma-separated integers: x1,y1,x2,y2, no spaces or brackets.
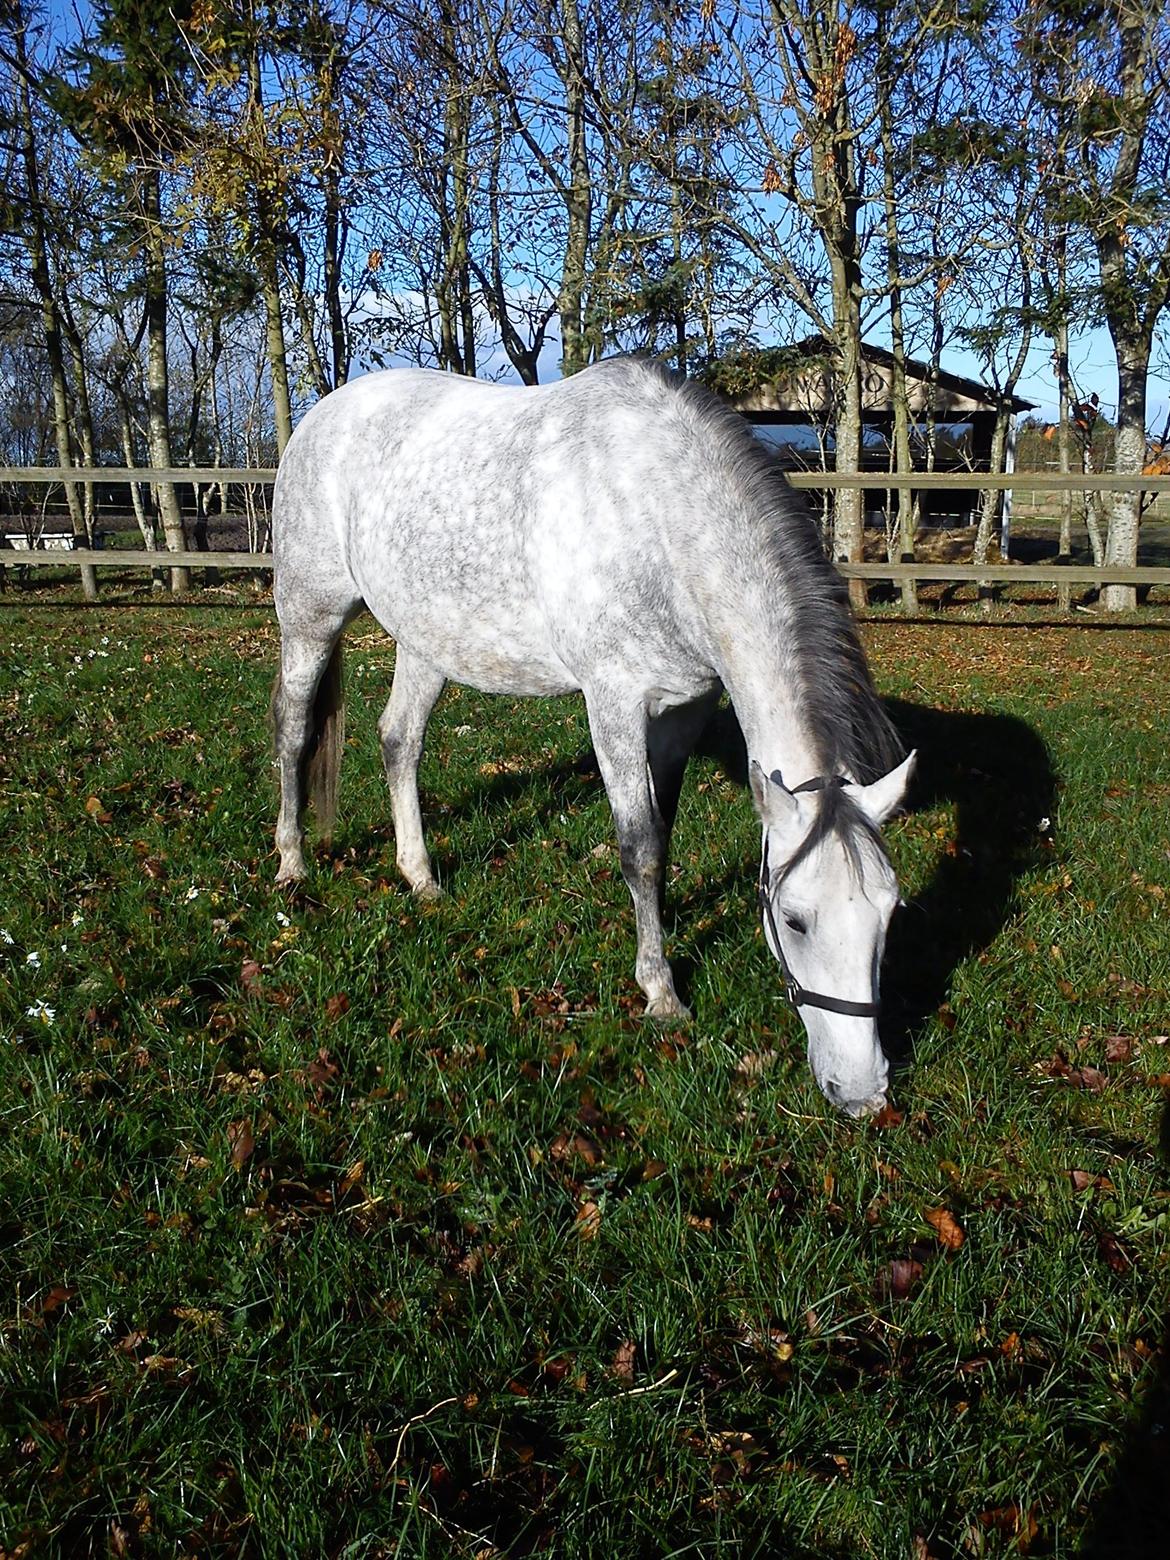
275,360,733,699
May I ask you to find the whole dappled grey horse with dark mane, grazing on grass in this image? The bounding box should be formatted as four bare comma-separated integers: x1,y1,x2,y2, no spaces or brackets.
273,359,913,1115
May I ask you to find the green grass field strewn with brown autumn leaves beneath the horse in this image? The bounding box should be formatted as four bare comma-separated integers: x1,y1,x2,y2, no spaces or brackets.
0,597,1170,1560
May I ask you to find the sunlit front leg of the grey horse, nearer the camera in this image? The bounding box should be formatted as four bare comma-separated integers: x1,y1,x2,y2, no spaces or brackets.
585,691,690,1019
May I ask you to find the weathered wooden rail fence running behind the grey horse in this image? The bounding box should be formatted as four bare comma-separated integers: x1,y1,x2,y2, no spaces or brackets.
0,466,1170,587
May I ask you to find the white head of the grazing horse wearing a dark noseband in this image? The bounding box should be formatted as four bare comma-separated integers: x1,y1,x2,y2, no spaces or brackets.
750,753,914,1115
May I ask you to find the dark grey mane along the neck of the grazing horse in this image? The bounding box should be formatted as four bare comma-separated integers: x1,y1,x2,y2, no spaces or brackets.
608,360,905,786
